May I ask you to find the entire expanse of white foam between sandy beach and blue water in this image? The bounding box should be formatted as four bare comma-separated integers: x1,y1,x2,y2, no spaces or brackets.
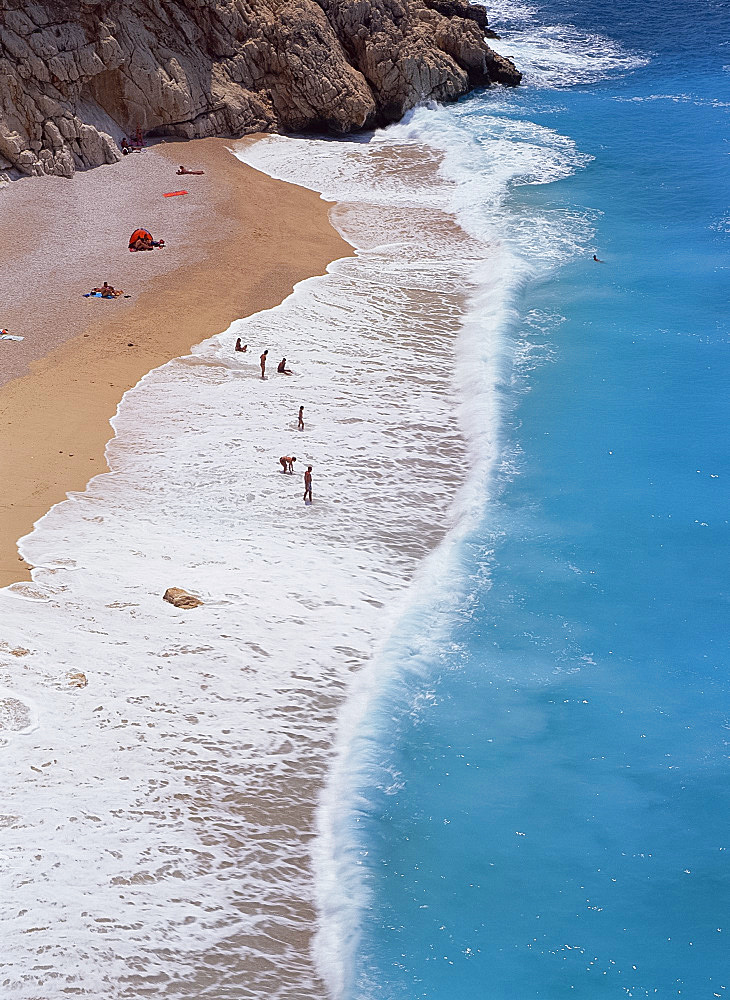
0,21,590,1000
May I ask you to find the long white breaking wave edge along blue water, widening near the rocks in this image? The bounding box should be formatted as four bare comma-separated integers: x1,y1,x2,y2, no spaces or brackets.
237,92,592,998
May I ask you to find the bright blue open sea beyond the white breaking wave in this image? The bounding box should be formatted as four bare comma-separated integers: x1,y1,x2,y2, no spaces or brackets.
350,0,730,1000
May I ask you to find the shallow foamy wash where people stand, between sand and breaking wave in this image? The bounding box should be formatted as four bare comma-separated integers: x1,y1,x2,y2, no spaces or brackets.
0,125,477,1000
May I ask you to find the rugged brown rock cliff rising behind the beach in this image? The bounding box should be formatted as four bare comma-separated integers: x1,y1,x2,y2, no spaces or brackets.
0,0,520,176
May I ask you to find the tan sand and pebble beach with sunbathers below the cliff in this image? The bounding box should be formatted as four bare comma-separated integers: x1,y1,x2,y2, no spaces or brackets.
0,133,352,586
